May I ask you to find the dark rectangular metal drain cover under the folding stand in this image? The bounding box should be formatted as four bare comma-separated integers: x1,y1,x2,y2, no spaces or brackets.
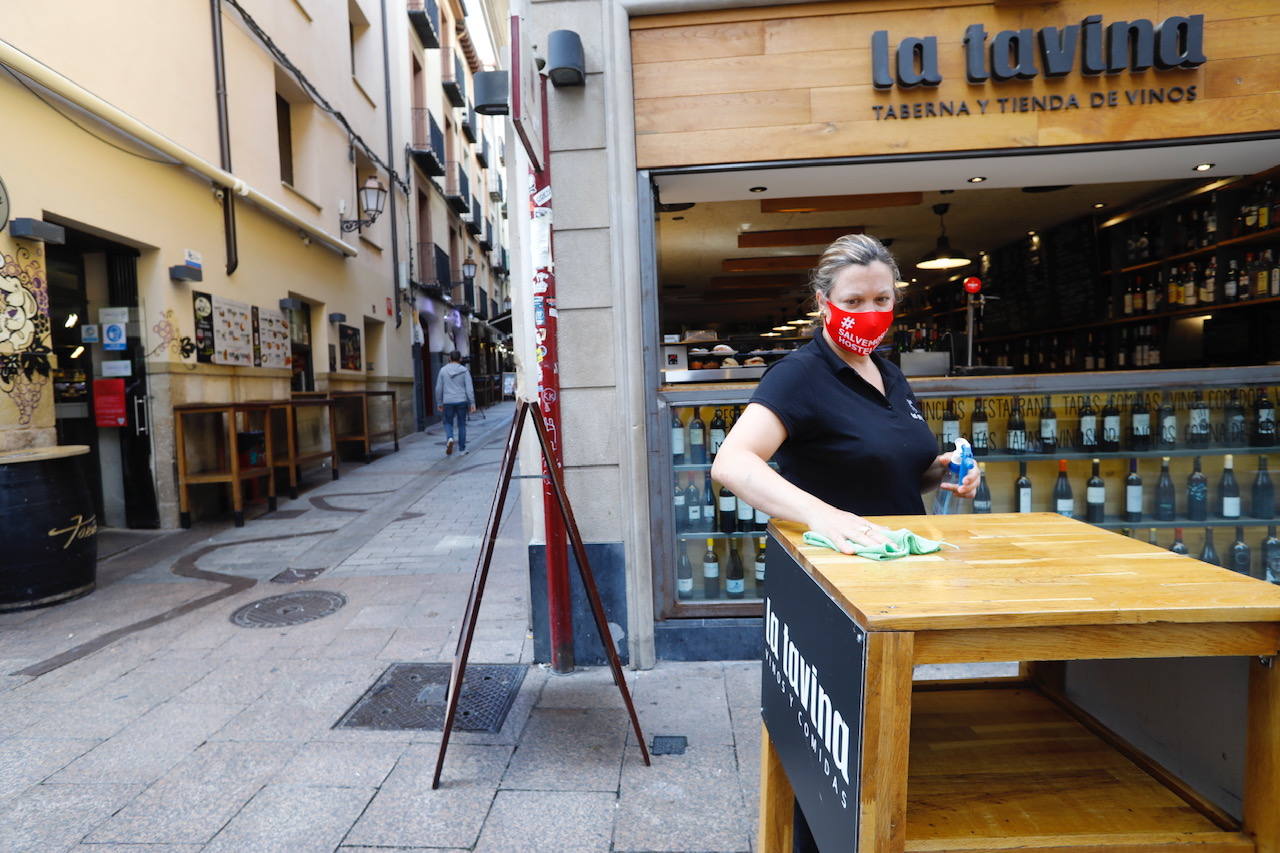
334,663,529,734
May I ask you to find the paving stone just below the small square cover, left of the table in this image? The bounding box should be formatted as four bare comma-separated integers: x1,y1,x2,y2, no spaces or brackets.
613,744,750,852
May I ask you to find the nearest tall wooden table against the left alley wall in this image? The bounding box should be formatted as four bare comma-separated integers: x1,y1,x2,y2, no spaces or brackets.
173,401,275,528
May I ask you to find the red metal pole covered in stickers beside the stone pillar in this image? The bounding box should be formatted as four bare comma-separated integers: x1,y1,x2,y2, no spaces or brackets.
530,74,573,675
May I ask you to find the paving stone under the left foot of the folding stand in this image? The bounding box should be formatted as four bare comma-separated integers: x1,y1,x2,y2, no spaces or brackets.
346,744,511,849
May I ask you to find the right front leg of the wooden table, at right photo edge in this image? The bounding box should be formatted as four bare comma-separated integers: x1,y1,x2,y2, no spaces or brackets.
1243,657,1280,853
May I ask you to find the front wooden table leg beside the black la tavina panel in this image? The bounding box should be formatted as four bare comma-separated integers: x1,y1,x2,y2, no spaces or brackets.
858,631,915,853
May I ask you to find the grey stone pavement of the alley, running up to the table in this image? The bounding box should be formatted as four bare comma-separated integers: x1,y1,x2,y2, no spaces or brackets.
0,403,760,853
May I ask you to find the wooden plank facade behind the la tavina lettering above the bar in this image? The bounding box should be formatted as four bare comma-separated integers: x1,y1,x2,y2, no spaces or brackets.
632,0,1280,168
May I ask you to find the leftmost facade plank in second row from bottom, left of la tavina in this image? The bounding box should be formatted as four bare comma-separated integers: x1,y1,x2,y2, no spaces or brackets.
636,88,818,133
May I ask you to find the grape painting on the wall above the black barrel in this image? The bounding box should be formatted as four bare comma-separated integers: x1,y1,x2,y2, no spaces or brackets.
0,246,51,427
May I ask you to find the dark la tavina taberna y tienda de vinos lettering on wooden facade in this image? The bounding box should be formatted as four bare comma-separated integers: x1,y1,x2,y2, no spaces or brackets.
872,15,1204,120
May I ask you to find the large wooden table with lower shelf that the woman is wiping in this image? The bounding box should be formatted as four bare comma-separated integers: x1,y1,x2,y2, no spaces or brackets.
759,514,1280,853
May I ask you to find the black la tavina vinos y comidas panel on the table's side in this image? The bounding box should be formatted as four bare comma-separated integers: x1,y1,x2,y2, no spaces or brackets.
760,534,867,853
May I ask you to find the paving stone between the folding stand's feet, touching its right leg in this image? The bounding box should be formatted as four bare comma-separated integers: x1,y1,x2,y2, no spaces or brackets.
502,708,628,792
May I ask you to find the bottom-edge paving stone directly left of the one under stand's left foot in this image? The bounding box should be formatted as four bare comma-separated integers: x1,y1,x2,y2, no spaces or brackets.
205,785,374,853
